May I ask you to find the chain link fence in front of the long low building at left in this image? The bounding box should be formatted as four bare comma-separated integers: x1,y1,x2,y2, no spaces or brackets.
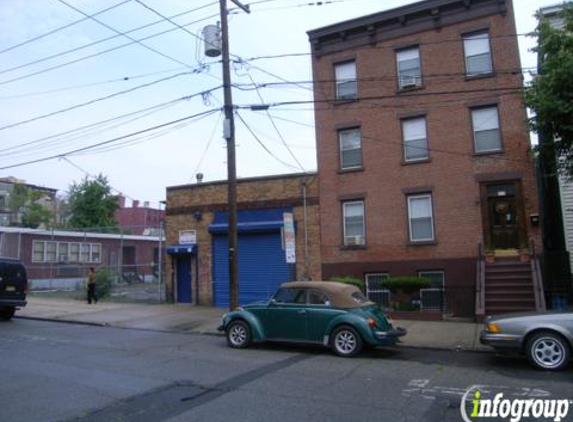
0,227,166,303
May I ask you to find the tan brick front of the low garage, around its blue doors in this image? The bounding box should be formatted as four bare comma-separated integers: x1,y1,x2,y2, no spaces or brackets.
166,174,321,305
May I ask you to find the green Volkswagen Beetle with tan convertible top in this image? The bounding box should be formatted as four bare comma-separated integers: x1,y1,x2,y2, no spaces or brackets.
218,281,406,357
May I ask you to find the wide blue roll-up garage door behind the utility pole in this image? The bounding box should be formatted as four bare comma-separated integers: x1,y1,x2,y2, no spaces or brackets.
213,230,289,307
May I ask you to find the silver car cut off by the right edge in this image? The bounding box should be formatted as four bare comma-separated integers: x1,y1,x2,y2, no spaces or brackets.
480,312,573,371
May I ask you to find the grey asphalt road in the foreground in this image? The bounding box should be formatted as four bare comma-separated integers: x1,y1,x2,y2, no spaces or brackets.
0,319,573,422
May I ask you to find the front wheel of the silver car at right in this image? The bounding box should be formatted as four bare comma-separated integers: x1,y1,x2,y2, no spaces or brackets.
526,331,571,371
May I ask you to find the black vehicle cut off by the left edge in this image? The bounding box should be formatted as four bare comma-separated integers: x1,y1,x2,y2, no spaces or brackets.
0,258,28,321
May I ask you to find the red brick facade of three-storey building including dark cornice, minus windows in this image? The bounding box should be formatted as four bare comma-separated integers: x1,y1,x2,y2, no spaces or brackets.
309,0,540,294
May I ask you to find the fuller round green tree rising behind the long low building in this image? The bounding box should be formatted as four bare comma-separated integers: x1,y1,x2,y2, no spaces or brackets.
69,174,118,228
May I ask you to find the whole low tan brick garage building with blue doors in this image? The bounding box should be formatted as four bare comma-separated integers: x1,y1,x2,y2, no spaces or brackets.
166,174,321,307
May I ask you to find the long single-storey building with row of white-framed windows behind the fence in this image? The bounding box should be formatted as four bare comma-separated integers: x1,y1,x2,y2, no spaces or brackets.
0,226,163,290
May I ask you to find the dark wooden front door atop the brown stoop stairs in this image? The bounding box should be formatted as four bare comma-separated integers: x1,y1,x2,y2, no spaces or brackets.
486,184,520,249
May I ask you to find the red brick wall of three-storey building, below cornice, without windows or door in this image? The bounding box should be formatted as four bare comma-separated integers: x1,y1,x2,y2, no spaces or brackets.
311,1,541,284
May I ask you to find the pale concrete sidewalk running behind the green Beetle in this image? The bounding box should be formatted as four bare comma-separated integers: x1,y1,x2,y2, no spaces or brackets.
16,297,492,351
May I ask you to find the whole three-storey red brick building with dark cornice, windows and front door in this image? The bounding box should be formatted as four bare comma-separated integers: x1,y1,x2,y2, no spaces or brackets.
308,0,540,315
